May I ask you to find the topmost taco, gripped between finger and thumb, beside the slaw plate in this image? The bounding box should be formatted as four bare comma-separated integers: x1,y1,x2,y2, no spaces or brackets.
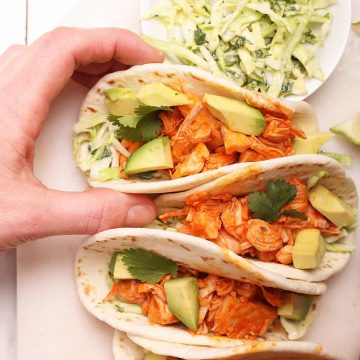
74,64,333,193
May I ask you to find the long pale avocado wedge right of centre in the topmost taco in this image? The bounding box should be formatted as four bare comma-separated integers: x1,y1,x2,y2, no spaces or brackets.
203,94,266,136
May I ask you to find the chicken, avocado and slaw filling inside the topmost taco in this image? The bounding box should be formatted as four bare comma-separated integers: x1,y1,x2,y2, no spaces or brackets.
74,83,312,181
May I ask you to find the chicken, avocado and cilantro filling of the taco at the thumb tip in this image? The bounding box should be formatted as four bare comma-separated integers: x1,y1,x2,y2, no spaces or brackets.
158,174,356,269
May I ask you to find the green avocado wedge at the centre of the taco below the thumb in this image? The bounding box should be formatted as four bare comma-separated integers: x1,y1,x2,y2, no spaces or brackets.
164,277,200,331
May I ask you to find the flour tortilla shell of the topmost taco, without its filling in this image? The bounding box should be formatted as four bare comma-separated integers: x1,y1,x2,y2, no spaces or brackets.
74,64,317,194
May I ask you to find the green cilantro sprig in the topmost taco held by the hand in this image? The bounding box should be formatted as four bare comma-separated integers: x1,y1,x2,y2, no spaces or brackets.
107,105,171,141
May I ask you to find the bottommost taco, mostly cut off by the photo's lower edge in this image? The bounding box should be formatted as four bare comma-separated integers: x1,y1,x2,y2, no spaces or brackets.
113,330,341,360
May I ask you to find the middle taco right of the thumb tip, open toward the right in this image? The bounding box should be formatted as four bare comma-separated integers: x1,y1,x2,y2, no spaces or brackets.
152,155,358,281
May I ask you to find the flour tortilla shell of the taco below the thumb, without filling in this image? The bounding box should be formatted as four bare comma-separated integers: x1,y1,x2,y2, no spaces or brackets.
76,228,326,347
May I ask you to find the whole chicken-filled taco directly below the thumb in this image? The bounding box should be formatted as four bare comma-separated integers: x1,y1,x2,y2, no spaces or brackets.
76,228,326,348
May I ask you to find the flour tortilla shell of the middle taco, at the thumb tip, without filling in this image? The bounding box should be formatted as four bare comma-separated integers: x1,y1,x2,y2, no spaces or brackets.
155,155,358,282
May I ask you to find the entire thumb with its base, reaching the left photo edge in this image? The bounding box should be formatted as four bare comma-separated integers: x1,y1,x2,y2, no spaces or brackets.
0,180,156,251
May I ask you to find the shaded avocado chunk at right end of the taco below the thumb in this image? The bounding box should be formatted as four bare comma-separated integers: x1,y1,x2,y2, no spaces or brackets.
278,293,312,321
